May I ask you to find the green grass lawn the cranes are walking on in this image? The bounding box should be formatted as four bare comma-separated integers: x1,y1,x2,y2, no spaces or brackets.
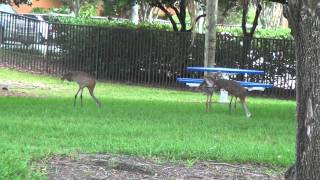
0,69,296,179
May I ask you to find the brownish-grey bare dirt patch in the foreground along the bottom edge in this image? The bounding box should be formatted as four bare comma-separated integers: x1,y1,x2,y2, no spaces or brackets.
47,154,283,180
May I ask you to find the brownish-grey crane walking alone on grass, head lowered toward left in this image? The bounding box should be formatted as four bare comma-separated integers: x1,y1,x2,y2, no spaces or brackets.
61,71,101,107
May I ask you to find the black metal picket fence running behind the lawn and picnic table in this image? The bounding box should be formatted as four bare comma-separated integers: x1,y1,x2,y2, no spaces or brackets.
0,12,296,98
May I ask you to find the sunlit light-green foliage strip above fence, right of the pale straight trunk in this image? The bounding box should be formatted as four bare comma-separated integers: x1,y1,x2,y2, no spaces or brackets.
217,27,293,40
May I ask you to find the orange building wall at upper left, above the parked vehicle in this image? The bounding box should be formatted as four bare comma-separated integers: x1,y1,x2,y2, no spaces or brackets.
13,0,63,13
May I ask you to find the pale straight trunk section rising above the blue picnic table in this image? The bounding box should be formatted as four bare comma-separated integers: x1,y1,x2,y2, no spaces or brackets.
204,0,218,67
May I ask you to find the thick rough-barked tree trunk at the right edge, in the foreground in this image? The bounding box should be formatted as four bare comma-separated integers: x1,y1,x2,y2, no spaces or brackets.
286,0,320,180
